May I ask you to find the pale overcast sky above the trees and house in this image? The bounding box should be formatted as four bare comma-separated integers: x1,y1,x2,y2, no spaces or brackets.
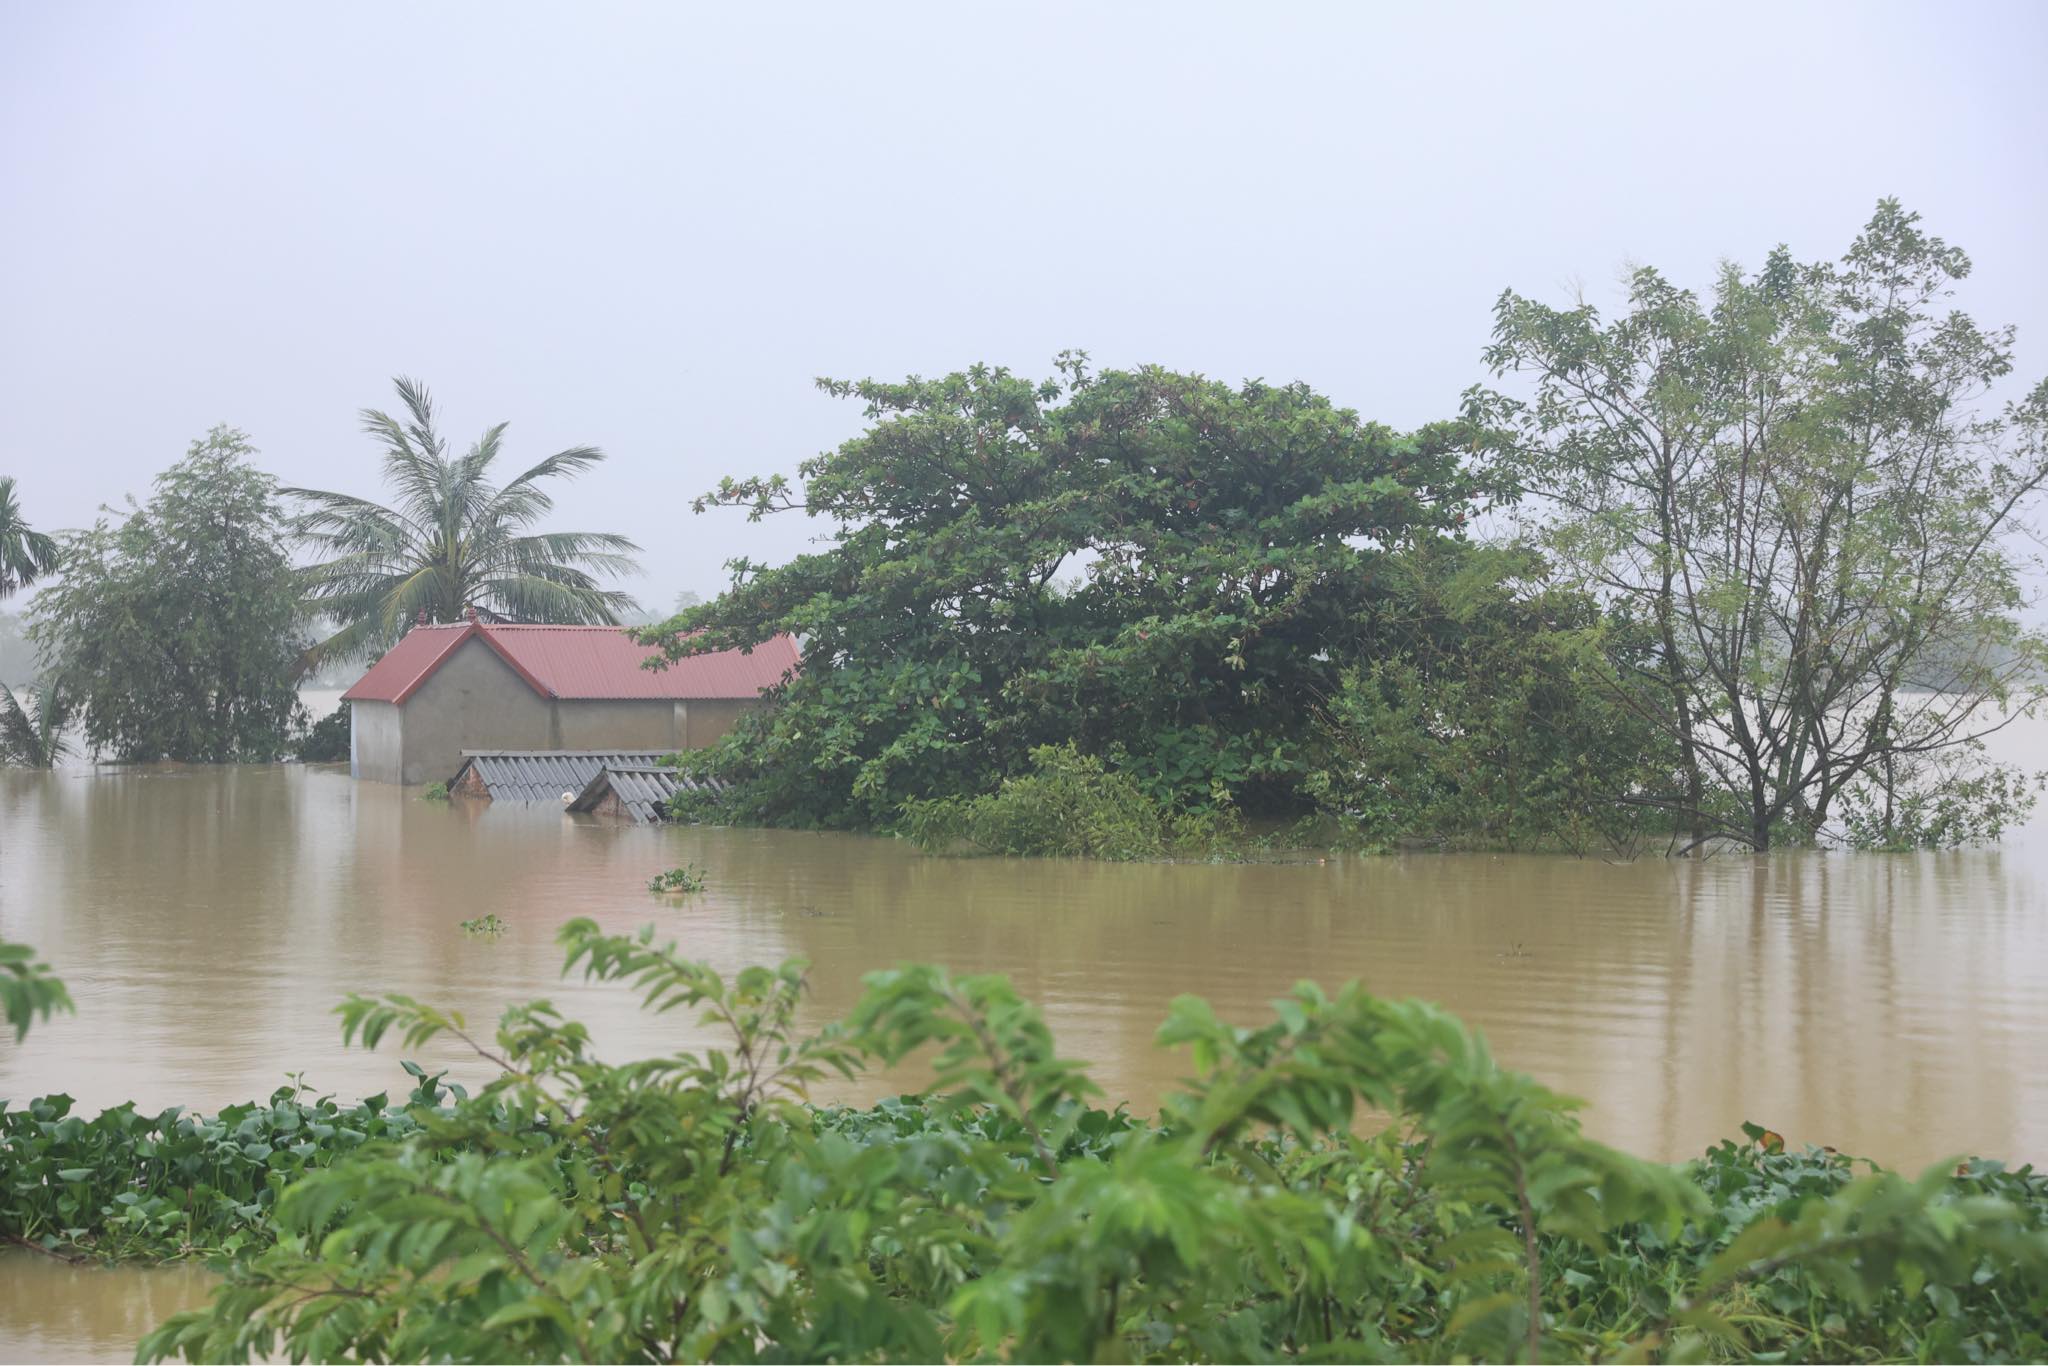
0,0,2048,602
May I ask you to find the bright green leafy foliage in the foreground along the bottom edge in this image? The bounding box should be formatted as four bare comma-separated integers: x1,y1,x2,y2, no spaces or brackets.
141,922,2048,1360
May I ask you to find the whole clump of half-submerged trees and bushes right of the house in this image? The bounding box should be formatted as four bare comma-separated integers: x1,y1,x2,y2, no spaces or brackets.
643,201,2048,854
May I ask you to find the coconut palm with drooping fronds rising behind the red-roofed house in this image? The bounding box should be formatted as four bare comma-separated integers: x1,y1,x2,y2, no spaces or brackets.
285,379,639,668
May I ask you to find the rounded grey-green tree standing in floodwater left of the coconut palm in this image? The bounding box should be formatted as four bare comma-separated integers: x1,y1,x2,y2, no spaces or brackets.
29,426,305,762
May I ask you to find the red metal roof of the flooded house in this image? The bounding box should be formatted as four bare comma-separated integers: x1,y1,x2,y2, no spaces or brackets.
342,623,797,702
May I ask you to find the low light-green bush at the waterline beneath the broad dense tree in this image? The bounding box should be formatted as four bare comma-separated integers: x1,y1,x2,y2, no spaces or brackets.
903,743,1239,860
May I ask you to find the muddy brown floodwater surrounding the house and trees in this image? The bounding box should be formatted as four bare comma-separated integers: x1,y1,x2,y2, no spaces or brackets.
0,753,2048,1360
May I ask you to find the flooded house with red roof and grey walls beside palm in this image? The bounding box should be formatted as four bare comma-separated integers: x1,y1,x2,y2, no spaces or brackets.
342,616,797,782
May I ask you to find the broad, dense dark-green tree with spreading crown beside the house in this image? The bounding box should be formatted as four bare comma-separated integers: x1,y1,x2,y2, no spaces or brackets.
649,356,1470,825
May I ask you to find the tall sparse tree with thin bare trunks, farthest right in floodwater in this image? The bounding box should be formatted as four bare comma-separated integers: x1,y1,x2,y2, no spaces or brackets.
1470,201,2048,850
